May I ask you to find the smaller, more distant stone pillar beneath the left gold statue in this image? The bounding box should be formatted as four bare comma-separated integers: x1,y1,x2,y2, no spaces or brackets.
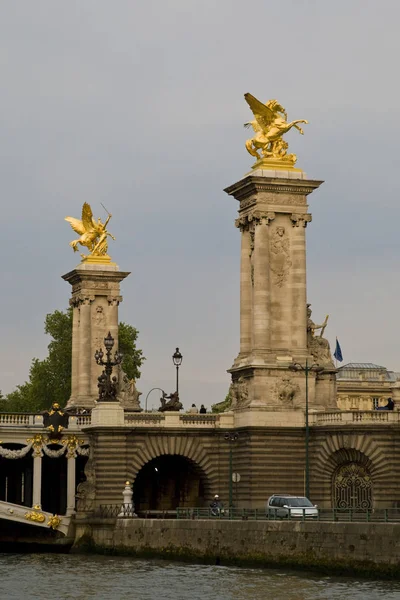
63,262,129,409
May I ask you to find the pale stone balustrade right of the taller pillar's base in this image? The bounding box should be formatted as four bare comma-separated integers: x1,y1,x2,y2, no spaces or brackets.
309,410,400,426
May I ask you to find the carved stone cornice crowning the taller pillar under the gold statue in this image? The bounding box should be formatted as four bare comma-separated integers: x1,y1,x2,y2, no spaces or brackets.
224,175,323,203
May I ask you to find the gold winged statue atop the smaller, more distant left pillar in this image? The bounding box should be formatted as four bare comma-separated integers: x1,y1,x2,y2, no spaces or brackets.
65,202,115,260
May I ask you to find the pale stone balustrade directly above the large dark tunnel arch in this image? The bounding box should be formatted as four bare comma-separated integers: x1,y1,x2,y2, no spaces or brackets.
125,412,234,429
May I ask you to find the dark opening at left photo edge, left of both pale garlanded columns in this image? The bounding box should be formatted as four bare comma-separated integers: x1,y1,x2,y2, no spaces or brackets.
0,443,33,506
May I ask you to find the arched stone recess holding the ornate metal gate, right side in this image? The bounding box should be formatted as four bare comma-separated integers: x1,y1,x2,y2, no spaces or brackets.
332,448,373,510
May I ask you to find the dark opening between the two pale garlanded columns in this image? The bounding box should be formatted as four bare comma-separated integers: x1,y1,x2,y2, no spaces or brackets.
42,444,67,515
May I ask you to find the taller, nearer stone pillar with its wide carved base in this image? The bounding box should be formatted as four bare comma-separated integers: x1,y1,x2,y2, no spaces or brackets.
225,170,335,418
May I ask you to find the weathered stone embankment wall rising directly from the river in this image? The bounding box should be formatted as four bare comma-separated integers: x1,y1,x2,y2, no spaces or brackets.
73,518,400,578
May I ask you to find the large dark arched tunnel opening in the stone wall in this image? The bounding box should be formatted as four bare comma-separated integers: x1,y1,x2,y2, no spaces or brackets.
134,454,208,512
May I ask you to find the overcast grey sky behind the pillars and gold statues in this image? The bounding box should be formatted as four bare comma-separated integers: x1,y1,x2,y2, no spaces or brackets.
0,0,400,405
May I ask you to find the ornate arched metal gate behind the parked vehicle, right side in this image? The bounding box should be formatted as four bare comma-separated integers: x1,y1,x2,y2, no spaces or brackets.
333,463,372,510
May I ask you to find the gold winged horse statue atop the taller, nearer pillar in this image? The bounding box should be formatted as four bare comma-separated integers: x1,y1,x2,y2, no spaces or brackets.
244,94,308,167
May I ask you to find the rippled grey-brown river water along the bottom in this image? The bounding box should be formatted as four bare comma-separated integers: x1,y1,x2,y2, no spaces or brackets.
0,554,400,600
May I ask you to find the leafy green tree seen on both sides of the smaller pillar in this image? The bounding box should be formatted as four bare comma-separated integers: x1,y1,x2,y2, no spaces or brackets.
2,309,145,412
